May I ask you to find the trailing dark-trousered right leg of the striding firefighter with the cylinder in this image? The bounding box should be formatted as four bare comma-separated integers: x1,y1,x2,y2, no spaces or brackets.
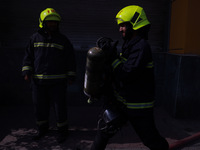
130,110,169,150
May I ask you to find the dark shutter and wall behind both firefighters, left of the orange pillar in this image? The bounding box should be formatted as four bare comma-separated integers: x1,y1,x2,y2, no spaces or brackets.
0,0,169,105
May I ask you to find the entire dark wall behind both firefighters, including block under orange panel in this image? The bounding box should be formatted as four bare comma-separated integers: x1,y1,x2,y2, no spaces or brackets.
0,0,200,117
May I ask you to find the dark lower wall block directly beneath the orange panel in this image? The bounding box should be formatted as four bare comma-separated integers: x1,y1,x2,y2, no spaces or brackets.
154,53,200,118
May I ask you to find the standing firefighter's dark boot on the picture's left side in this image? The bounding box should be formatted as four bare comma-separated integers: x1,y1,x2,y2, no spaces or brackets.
33,122,49,140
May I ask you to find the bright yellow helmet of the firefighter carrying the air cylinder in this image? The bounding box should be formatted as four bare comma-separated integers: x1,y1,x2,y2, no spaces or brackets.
116,5,150,30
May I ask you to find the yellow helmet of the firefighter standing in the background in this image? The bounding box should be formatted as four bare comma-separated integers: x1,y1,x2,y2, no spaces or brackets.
39,8,61,28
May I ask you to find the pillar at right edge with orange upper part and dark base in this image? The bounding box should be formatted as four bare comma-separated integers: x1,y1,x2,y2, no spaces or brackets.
163,0,200,117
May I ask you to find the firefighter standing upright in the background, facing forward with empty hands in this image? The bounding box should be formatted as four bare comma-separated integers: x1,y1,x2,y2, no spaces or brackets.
22,8,76,143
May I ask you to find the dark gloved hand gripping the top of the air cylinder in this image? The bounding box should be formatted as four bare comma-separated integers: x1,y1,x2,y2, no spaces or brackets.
96,37,118,63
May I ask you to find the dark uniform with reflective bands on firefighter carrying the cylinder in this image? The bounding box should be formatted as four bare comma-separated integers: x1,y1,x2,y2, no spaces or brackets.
91,36,168,150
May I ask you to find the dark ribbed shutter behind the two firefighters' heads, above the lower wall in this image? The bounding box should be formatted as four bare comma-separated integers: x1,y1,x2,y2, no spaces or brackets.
0,0,169,51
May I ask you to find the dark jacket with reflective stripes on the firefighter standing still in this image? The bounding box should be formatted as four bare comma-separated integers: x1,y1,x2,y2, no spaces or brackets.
22,29,76,84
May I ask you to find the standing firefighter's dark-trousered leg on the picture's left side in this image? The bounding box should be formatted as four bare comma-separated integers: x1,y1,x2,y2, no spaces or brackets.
32,85,50,140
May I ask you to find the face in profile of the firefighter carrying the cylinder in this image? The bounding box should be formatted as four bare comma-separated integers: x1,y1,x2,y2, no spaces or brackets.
119,23,133,40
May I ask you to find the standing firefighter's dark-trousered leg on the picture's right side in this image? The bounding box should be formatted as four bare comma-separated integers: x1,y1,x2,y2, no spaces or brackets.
50,83,68,143
